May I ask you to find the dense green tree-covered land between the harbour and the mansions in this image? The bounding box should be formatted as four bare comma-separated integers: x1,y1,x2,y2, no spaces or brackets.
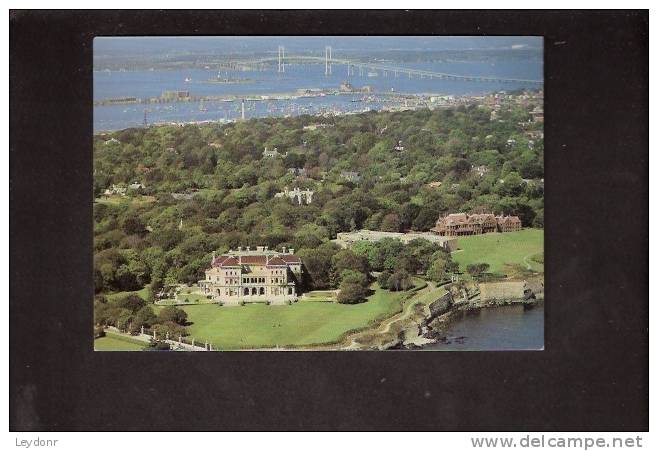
94,102,544,300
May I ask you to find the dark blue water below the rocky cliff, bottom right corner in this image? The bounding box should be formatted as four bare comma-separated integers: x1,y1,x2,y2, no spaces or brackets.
423,304,544,351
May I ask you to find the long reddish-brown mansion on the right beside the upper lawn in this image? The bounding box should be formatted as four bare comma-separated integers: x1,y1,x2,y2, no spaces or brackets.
432,213,521,236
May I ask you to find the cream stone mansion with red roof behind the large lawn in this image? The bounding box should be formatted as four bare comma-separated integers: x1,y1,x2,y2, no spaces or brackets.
199,246,302,304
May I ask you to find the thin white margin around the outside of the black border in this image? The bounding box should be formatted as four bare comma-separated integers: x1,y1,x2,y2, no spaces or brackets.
0,0,658,451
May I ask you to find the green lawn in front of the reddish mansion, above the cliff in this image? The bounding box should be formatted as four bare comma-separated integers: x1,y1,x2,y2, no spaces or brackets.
452,229,544,274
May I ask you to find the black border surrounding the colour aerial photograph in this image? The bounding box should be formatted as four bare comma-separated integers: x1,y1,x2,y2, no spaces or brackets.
9,10,649,431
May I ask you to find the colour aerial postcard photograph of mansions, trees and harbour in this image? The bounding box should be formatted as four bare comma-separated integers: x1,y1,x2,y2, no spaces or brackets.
89,36,550,351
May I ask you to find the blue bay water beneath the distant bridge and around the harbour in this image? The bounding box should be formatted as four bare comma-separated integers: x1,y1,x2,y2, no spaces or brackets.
94,59,543,132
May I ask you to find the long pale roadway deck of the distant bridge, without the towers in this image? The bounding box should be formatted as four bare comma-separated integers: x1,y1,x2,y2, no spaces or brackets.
223,56,544,85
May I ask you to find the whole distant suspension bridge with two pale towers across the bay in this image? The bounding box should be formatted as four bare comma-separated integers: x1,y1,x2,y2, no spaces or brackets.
221,46,544,85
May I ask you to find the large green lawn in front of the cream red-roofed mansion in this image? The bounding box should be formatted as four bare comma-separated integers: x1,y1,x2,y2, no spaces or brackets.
163,287,404,349
